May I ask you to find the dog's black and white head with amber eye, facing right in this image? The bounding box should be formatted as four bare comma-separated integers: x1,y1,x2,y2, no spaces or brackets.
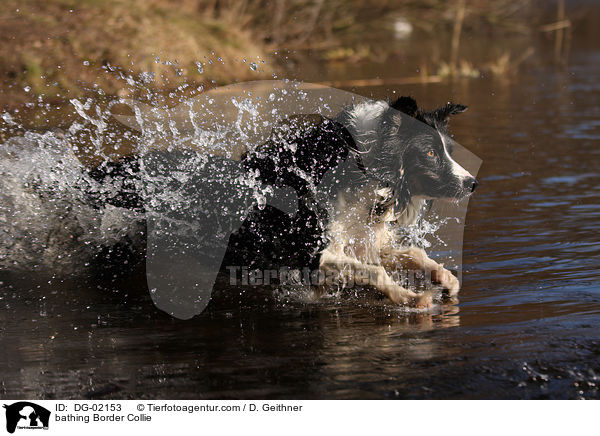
346,97,477,211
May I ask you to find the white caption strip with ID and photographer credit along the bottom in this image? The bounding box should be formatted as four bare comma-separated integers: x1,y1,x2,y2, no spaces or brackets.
0,400,598,436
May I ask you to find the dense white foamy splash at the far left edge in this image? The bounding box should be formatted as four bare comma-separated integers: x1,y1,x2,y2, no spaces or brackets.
0,127,143,273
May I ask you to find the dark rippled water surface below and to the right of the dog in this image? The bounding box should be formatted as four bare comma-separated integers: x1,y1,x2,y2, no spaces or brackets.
0,40,600,399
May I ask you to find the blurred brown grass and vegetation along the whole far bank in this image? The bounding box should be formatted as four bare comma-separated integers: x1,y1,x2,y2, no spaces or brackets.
0,0,560,107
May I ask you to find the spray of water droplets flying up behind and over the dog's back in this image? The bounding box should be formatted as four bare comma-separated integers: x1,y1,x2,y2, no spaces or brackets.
0,64,478,316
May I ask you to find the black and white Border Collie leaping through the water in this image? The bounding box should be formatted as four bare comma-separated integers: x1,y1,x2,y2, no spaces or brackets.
239,97,477,307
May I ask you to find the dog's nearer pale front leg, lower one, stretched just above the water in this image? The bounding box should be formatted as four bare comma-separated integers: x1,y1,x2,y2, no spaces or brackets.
319,250,432,308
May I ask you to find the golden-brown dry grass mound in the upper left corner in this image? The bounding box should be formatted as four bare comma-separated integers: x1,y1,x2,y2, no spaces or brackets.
0,0,270,105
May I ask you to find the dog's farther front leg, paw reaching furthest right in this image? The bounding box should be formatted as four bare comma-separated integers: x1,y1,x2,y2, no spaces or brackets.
380,247,460,295
